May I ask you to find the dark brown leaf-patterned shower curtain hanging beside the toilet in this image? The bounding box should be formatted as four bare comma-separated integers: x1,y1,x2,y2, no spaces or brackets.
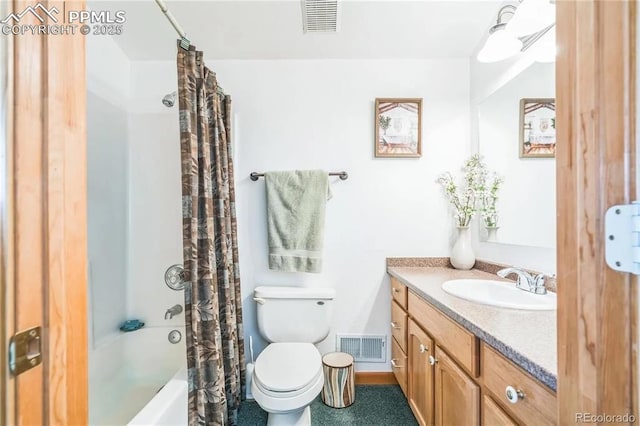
178,46,245,426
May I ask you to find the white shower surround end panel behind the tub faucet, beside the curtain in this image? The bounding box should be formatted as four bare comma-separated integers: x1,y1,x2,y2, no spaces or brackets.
128,109,186,326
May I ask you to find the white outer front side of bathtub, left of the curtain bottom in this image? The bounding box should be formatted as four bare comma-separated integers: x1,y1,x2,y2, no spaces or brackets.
127,369,188,426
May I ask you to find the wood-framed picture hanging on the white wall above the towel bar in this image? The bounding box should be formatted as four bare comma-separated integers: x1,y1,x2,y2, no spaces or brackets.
375,98,422,158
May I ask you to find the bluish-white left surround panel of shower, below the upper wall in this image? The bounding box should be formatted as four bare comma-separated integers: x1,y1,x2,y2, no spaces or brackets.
87,92,128,345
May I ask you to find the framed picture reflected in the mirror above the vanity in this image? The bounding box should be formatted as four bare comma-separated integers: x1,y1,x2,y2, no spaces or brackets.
520,98,556,158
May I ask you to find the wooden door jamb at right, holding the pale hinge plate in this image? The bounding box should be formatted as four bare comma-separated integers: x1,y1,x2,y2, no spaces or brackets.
556,0,638,424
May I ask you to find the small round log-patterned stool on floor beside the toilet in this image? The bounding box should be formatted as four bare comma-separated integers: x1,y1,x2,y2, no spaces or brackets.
322,352,356,408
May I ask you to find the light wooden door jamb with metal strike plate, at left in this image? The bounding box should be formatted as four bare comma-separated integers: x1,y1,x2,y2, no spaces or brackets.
1,0,88,426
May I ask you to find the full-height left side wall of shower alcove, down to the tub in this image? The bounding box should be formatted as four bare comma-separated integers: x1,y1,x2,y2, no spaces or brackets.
87,33,130,347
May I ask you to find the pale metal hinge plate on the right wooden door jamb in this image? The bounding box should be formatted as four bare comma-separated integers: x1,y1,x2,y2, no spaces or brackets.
604,201,640,275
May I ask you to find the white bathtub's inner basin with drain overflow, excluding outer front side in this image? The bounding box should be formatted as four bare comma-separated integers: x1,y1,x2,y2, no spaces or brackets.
89,325,187,426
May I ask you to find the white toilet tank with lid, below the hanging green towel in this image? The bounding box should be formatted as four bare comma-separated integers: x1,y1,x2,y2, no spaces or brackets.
253,286,335,343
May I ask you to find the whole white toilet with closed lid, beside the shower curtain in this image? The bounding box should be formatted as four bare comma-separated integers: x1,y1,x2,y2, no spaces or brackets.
251,287,335,426
